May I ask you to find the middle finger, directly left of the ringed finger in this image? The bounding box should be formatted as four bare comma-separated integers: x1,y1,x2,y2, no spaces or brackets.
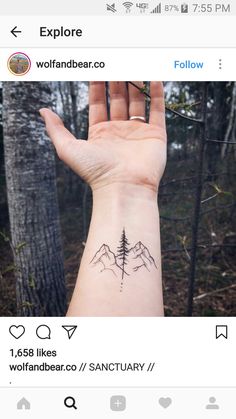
109,81,128,121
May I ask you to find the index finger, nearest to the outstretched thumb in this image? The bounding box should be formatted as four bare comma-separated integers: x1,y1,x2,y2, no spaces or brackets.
89,81,107,126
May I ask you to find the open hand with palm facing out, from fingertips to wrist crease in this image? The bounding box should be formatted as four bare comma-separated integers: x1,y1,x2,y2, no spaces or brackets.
40,82,166,191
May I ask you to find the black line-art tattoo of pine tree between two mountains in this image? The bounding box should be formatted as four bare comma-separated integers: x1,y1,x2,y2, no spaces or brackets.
90,228,157,292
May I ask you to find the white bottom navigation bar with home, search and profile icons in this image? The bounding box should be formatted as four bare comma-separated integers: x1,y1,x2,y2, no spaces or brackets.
0,387,236,419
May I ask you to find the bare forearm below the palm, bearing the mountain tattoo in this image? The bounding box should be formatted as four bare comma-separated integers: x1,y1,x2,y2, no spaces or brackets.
68,184,163,316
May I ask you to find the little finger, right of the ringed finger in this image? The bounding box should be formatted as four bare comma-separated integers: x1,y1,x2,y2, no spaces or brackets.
149,81,165,128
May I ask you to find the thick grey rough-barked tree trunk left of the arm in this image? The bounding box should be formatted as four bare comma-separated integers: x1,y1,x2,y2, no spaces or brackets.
3,82,66,316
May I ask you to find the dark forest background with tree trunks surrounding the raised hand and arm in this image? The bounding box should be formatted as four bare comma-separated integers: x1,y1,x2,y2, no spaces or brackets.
0,82,236,316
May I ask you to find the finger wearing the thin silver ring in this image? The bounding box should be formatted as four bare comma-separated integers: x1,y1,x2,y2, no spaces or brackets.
129,81,145,118
